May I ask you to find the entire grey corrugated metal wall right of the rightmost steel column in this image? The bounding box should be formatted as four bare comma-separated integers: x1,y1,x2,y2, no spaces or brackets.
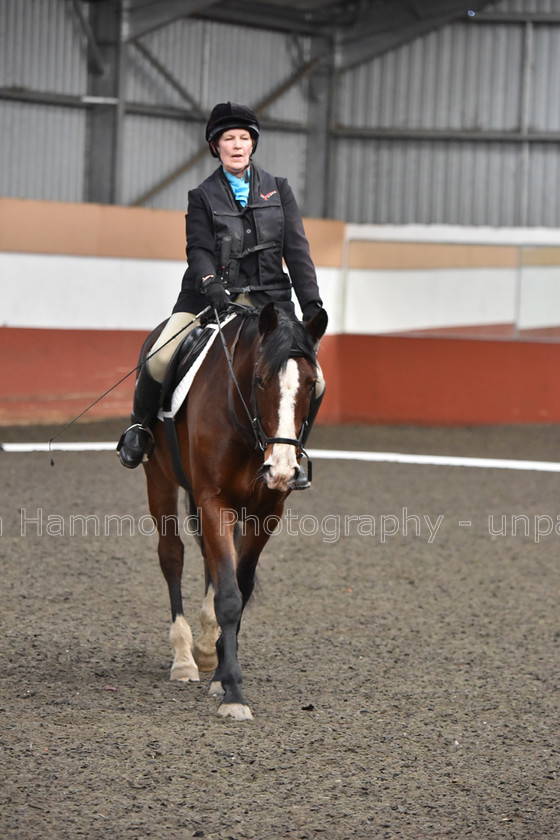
331,0,560,226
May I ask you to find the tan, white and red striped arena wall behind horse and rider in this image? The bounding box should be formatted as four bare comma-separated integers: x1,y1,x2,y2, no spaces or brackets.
0,199,560,425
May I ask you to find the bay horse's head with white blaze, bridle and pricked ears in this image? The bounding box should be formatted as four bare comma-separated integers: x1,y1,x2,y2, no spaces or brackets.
253,304,327,492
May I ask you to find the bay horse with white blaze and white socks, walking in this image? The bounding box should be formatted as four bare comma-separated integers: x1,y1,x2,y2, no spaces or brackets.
144,303,327,720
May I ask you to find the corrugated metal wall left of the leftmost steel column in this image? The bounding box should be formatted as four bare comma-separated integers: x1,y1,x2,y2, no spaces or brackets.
0,0,87,201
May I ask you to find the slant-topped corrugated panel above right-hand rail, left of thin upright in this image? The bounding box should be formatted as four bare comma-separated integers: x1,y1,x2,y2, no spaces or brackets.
337,23,523,131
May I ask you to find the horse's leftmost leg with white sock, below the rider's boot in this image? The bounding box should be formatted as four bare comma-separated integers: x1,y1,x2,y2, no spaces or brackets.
144,459,200,682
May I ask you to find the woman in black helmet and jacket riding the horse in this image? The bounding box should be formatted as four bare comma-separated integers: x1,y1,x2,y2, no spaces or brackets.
117,102,324,489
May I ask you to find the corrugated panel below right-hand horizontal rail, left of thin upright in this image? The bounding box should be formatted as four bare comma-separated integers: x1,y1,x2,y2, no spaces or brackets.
333,140,521,226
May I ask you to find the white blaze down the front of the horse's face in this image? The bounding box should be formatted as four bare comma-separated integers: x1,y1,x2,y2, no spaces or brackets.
265,359,299,490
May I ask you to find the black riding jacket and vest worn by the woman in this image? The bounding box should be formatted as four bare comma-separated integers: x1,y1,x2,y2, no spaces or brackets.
173,164,322,312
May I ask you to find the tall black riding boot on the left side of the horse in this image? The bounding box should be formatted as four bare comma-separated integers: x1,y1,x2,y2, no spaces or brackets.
117,364,161,470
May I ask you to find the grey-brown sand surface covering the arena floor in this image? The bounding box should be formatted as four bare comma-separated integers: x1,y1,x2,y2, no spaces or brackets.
0,423,560,840
